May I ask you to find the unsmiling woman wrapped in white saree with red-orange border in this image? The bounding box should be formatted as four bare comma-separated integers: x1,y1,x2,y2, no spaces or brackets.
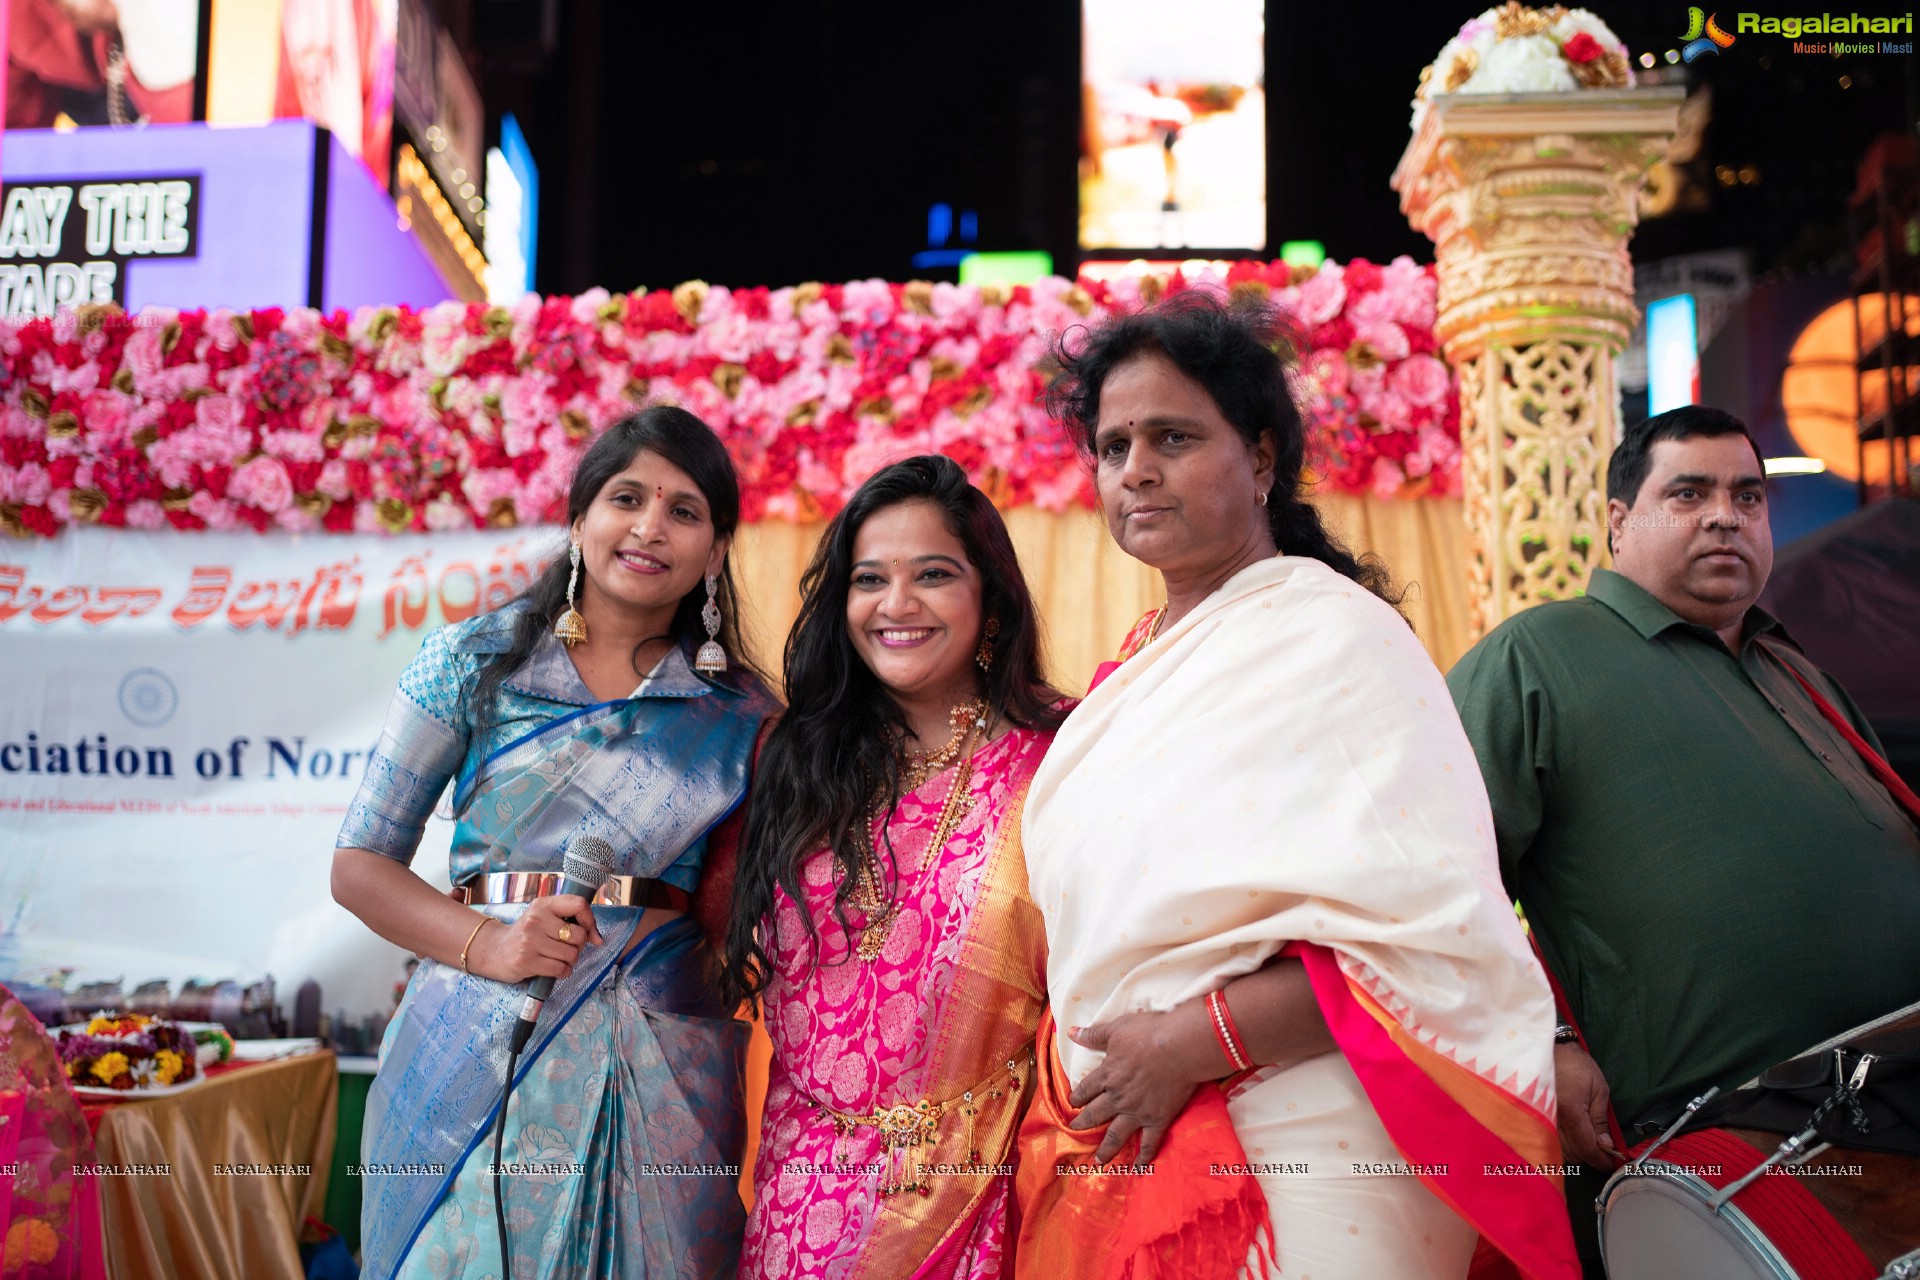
1018,292,1578,1280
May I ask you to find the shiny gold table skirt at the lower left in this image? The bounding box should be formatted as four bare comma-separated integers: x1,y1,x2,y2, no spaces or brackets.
88,1052,338,1280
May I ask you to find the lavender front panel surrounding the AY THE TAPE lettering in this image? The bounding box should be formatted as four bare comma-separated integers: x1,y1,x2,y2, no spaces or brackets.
6,121,315,311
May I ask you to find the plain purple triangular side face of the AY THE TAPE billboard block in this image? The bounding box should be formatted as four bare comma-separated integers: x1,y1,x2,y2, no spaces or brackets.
321,138,453,311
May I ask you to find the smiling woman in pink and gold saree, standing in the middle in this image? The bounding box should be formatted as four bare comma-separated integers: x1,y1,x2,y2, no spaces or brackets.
726,457,1066,1280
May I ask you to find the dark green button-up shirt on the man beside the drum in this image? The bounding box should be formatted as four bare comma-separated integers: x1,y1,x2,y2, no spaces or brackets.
1448,570,1920,1125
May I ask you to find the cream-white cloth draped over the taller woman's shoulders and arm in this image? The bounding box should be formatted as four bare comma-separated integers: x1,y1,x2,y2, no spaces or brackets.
1023,557,1553,1117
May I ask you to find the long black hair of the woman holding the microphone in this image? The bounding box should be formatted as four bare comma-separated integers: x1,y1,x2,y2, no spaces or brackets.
468,405,758,722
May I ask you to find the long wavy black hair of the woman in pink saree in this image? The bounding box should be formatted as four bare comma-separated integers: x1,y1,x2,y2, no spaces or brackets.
722,455,1066,1006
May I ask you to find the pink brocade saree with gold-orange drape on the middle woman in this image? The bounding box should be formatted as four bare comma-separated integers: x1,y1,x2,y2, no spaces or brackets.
741,729,1052,1280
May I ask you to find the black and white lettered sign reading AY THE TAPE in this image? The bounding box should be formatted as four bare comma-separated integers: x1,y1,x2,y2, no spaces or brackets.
0,177,200,319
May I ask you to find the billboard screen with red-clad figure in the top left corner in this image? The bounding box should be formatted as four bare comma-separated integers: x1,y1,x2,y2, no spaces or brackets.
6,0,200,129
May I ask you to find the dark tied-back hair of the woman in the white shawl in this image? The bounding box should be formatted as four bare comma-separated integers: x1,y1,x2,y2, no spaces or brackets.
1046,290,1405,608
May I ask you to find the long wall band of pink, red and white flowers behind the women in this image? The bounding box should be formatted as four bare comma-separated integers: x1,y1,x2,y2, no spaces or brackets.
0,257,1459,535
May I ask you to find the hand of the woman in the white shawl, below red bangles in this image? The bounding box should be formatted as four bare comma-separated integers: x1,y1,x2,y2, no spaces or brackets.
1068,1013,1196,1165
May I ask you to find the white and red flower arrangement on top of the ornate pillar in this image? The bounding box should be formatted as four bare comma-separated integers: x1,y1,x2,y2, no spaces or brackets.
1413,0,1634,129
